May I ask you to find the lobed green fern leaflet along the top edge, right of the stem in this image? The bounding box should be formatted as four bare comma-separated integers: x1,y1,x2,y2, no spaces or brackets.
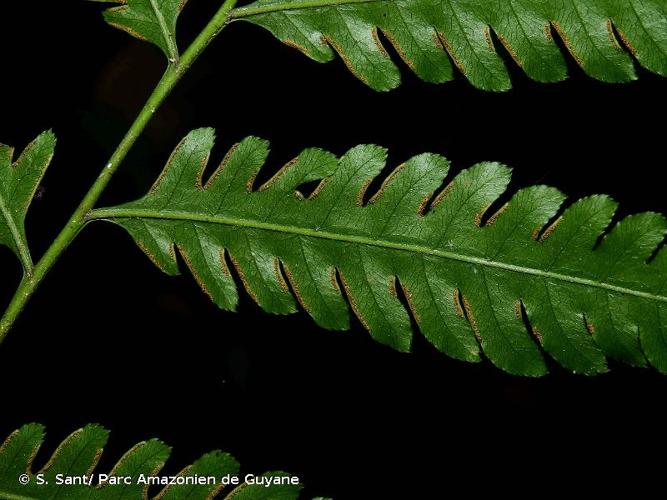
233,0,667,91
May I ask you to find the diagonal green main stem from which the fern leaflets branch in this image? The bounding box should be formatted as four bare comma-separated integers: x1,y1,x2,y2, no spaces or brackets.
0,0,237,343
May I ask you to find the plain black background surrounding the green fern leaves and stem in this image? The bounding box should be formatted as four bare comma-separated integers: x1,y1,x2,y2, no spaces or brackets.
0,0,667,498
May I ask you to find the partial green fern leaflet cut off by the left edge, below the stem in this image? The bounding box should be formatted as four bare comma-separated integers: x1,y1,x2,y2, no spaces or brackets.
0,132,56,275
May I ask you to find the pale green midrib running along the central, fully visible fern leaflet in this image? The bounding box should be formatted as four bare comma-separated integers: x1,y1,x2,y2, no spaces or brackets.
88,208,667,303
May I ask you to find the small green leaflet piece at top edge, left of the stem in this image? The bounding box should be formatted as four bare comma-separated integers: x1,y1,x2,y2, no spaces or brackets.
92,0,187,61
